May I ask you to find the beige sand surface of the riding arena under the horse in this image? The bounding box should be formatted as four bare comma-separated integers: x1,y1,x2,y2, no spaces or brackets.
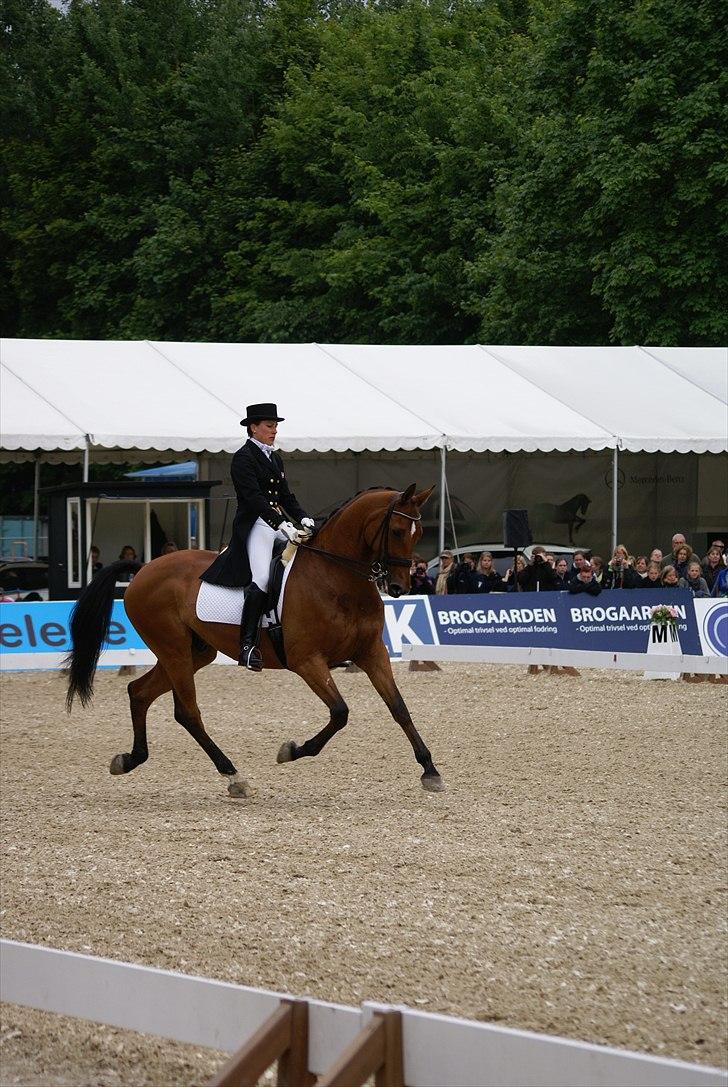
0,664,728,1085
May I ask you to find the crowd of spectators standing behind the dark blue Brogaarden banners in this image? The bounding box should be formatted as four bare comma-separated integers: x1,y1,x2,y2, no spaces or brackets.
410,533,728,597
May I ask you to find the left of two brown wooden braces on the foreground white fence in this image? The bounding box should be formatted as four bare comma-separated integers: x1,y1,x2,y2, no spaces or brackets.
209,1000,312,1087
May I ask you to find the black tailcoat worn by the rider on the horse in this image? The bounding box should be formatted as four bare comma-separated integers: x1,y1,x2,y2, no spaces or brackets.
202,440,306,588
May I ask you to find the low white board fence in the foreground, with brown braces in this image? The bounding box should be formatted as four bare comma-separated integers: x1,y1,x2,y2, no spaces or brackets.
0,940,728,1087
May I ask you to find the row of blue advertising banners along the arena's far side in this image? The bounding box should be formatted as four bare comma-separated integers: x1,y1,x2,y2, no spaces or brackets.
0,589,728,671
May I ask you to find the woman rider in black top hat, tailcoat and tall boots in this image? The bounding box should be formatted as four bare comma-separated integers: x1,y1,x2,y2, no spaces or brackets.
202,403,313,672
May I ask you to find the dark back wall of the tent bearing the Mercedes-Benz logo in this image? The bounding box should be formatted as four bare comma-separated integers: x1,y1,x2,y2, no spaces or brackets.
201,450,728,558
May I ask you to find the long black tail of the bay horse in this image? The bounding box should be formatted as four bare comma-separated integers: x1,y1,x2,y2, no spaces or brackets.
62,559,141,713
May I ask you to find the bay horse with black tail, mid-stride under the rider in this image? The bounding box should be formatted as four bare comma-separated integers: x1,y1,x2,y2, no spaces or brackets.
64,484,443,797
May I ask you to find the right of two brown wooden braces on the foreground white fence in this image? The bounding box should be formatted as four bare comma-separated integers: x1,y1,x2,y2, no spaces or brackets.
316,1011,404,1087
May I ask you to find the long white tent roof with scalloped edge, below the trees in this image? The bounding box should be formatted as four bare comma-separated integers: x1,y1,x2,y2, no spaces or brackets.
0,339,728,452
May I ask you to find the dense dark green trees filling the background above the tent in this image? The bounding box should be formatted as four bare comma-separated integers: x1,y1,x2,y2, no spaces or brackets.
0,0,728,345
